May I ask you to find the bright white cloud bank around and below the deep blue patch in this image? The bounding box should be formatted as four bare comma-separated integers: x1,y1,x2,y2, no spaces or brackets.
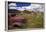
9,3,44,12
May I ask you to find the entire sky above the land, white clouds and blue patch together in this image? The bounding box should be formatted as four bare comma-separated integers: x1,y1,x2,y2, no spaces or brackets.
9,3,44,12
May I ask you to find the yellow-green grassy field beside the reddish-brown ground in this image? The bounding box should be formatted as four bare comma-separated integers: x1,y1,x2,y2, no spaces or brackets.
18,12,44,28
